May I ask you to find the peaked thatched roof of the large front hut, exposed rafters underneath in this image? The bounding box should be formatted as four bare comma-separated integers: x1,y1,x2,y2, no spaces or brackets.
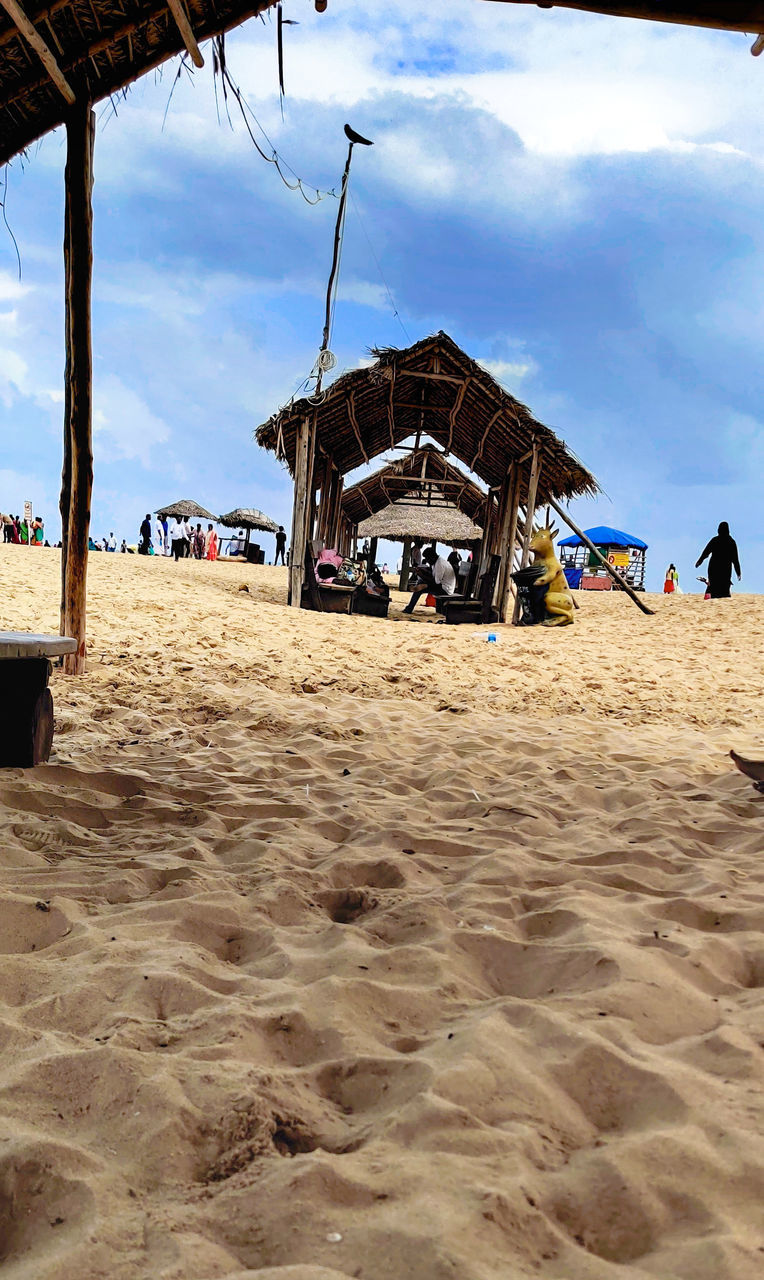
255,333,598,503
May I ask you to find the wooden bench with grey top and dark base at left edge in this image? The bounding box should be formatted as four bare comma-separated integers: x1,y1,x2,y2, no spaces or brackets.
0,631,77,769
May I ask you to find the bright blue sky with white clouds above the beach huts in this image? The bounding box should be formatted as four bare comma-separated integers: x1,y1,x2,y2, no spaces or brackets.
0,0,764,591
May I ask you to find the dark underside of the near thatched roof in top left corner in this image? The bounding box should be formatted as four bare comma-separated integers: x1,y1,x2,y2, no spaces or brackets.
0,0,275,164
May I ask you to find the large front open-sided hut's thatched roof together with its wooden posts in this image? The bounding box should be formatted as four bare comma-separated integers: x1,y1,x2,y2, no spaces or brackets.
255,333,598,620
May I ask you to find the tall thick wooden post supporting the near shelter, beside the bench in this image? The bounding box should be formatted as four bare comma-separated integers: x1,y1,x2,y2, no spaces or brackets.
60,102,96,676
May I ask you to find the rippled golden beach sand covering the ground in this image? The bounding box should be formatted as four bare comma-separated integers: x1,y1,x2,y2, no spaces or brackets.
0,547,764,1280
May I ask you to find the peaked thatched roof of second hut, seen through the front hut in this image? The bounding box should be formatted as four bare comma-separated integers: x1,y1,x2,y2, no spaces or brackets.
342,445,488,525
